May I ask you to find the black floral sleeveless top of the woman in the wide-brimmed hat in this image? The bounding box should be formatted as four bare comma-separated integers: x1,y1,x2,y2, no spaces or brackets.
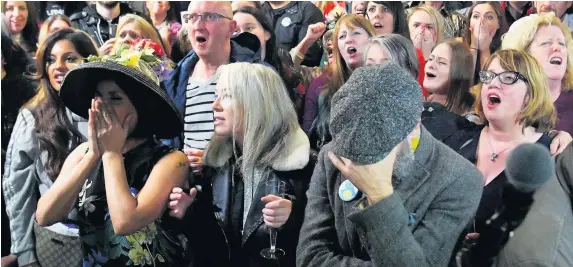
78,140,187,267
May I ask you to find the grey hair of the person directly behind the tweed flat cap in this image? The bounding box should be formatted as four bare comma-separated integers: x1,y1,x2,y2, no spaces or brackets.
364,33,420,80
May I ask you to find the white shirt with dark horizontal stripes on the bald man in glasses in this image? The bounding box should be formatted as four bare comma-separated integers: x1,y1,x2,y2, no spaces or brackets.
184,75,217,150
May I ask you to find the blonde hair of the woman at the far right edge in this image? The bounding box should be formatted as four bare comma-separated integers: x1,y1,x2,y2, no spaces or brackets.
501,12,573,91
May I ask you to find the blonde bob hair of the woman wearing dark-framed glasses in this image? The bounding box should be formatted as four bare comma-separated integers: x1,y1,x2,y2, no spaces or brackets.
475,49,557,132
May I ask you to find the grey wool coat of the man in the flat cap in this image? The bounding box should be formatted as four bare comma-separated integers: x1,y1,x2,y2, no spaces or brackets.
297,128,483,267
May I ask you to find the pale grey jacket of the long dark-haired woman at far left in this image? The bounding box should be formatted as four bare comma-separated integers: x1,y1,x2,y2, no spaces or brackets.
2,109,87,266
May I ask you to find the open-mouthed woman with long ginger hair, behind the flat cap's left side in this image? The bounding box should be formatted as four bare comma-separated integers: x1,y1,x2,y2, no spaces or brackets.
303,14,376,149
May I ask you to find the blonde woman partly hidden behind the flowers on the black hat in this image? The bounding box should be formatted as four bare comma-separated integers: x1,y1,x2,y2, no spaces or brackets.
99,14,169,57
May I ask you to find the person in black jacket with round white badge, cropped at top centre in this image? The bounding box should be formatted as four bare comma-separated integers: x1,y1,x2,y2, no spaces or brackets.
263,1,323,67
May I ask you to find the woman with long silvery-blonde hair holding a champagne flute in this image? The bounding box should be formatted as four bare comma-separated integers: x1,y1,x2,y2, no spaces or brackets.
169,63,315,266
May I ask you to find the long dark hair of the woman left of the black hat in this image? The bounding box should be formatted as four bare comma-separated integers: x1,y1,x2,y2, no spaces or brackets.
27,29,98,180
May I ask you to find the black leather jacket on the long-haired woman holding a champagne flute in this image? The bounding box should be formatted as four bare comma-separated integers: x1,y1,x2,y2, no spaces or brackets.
185,146,317,267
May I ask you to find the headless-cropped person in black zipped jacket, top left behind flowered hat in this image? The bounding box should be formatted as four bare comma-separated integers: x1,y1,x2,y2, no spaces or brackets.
70,1,145,46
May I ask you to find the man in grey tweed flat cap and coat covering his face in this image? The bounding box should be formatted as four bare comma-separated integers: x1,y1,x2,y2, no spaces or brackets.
297,63,483,267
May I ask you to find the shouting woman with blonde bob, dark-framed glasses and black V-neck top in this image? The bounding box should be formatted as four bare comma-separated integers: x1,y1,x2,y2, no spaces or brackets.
434,50,568,266
